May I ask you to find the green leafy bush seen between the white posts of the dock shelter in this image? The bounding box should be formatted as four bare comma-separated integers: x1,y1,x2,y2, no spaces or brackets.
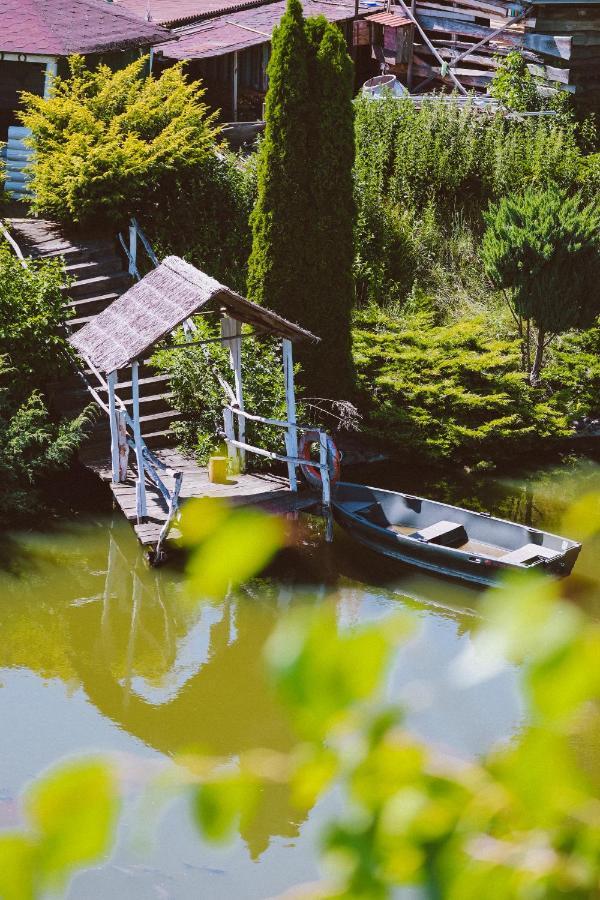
153,316,294,469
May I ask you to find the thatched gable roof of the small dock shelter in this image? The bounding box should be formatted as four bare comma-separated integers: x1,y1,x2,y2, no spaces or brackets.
69,256,319,372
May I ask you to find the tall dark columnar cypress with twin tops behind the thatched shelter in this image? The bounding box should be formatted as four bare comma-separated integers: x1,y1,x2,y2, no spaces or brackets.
248,0,354,397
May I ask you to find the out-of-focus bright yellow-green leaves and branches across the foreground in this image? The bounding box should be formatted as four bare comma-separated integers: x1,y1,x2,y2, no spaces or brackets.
0,493,600,900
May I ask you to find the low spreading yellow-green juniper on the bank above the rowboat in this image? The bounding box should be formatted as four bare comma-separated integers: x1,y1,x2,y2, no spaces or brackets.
354,307,568,464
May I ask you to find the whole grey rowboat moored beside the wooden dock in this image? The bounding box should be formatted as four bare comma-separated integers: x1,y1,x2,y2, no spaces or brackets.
332,482,581,585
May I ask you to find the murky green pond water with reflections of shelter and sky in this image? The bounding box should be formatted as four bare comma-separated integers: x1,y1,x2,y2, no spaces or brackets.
0,462,600,900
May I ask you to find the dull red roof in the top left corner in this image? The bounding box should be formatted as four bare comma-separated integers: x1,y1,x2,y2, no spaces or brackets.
0,0,169,56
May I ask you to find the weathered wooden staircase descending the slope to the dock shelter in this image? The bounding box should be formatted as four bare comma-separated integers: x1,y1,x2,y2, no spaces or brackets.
9,218,180,461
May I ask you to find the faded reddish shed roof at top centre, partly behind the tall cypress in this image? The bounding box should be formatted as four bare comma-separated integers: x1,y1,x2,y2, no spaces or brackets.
161,0,354,60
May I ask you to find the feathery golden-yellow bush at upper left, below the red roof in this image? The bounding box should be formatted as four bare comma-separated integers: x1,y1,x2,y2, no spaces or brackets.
20,56,223,224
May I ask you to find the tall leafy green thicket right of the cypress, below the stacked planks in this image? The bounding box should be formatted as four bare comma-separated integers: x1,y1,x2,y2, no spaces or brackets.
355,91,584,305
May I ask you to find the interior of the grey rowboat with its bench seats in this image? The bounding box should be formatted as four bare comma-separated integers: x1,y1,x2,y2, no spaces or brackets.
336,485,572,566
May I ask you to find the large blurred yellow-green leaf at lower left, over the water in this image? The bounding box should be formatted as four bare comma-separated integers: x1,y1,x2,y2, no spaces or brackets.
26,760,119,887
